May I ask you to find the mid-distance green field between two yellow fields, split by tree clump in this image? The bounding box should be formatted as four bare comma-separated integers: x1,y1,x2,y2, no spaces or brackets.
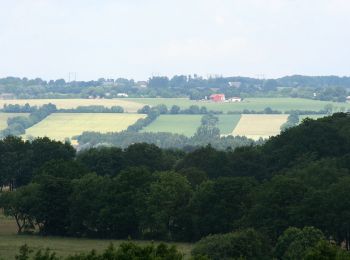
141,115,241,137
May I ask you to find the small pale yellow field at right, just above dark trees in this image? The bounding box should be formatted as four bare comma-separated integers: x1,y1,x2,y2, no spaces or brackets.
232,115,288,140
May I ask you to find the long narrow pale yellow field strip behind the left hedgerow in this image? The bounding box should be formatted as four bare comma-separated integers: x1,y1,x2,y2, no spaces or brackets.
0,98,144,113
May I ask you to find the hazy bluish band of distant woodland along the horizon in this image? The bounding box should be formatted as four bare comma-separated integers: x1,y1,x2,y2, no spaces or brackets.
0,75,350,102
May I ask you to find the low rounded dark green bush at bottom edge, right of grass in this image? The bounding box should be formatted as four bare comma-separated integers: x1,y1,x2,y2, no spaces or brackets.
192,229,271,260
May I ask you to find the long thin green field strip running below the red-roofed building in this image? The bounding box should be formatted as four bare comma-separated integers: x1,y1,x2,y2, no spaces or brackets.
127,98,350,113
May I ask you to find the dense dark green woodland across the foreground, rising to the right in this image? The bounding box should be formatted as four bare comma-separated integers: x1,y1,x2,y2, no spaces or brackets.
0,113,350,259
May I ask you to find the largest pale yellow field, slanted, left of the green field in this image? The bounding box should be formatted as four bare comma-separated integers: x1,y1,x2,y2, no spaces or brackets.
24,113,145,141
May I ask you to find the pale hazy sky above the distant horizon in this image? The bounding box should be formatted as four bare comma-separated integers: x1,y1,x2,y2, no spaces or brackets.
0,0,350,80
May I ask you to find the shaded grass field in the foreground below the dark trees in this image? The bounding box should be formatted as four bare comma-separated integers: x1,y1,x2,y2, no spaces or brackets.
0,213,192,260
